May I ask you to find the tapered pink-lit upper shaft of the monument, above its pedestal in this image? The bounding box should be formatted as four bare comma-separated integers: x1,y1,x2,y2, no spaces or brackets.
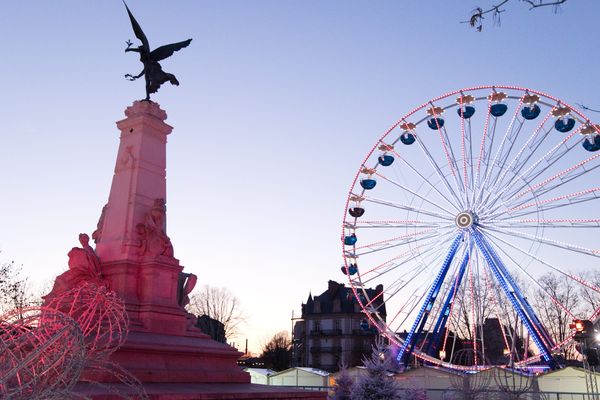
94,101,173,262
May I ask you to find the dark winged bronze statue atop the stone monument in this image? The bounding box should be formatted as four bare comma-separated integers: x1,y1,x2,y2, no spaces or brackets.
123,2,192,101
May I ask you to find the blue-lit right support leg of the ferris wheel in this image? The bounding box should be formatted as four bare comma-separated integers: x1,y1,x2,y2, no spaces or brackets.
471,228,555,366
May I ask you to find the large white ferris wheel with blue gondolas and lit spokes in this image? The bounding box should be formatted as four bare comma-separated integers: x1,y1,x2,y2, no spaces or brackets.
342,86,600,369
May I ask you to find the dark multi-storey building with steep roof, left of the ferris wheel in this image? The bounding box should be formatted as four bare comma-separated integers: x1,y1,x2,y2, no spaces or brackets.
292,281,386,372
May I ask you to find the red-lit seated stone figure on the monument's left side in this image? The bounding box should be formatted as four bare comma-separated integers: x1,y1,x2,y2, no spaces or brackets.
44,233,104,298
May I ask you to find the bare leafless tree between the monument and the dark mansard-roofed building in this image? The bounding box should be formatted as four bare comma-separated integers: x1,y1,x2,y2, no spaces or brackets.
186,285,245,341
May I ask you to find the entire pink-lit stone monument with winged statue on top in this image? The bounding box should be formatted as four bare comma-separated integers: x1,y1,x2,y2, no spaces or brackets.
45,3,326,400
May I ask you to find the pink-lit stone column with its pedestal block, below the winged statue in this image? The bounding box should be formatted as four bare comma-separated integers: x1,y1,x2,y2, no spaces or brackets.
93,101,186,334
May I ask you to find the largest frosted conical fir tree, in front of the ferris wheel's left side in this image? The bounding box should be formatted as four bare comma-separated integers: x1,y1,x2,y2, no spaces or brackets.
351,339,405,400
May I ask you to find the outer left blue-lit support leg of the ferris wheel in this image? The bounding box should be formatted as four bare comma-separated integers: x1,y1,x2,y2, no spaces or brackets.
396,231,464,364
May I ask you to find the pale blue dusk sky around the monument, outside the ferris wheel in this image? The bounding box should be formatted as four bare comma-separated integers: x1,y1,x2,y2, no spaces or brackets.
0,0,600,351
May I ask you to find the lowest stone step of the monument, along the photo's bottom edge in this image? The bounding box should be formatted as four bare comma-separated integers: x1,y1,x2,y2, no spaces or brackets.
75,383,327,400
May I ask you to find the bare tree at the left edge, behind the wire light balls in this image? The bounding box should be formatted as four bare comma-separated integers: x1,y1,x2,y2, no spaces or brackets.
0,261,33,314
